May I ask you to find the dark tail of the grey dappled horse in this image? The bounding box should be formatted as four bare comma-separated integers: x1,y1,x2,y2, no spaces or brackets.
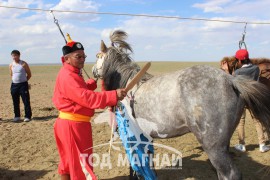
232,76,270,132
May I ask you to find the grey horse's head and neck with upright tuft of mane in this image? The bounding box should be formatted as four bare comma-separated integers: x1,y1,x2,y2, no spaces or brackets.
92,30,134,90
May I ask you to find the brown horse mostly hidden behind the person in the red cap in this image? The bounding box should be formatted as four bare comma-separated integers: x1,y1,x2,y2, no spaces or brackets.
220,56,270,89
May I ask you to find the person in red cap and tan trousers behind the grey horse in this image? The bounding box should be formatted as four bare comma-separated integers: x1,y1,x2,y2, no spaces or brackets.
233,49,270,152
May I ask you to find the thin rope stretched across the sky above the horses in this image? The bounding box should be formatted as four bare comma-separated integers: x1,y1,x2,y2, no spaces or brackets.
0,5,270,25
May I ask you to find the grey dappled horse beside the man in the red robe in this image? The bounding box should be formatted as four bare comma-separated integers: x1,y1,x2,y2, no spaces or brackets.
93,30,270,180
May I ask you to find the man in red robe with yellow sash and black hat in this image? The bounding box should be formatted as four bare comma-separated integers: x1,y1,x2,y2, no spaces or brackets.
53,35,126,180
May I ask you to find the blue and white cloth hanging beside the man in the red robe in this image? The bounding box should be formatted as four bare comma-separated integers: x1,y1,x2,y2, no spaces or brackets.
115,99,157,180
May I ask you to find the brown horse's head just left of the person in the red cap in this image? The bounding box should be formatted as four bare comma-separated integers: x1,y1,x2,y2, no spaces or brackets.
220,56,239,74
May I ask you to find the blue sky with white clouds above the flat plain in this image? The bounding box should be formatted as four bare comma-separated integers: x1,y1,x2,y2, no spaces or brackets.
0,0,270,65
